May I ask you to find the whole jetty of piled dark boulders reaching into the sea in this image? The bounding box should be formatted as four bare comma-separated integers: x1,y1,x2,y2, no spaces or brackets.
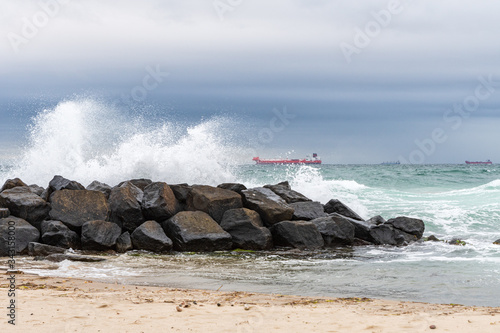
0,176,426,255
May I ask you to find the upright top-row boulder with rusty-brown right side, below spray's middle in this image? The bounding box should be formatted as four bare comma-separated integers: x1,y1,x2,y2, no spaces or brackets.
142,182,179,222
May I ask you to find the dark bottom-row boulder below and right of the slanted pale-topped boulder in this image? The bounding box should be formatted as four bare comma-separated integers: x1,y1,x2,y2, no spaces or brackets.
270,221,325,249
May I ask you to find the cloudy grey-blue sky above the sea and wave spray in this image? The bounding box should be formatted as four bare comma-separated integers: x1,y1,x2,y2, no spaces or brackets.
0,0,500,163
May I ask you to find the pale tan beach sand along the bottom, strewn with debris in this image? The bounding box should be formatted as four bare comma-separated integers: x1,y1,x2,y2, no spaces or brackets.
0,271,500,333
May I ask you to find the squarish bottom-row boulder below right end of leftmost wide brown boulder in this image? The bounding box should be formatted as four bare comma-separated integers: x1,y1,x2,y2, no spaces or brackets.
82,221,122,251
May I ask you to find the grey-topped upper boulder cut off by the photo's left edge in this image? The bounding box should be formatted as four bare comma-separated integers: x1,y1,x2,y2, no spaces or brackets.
0,186,50,229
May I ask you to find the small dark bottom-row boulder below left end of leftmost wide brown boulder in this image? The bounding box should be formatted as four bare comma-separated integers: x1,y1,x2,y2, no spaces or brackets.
41,221,80,249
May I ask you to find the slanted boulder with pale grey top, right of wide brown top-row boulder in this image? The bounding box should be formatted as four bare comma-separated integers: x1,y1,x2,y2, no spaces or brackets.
241,187,294,226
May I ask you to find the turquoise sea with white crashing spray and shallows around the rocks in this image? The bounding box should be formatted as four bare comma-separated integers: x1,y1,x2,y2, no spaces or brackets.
0,99,500,306
